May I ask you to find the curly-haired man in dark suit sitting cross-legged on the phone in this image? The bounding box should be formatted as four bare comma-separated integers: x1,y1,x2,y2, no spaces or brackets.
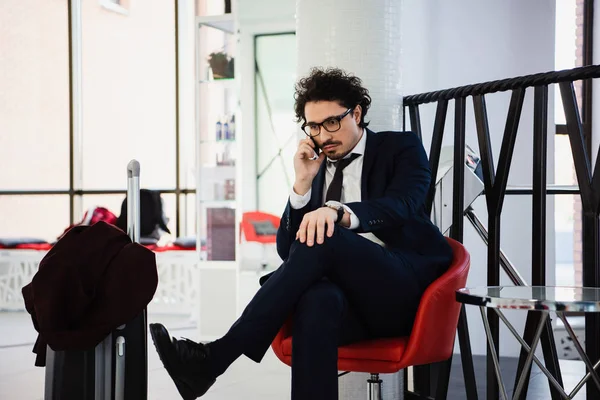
150,68,452,400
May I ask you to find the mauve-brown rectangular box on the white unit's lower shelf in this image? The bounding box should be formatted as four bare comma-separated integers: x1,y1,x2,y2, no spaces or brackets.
206,208,235,261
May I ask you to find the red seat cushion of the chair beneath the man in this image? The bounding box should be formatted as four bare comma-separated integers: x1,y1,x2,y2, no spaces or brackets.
281,337,408,374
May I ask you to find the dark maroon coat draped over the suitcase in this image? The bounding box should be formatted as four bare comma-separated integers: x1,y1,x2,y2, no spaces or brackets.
22,221,158,366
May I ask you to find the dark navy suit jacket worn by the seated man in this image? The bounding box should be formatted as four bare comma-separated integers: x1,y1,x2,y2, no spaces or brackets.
270,129,452,286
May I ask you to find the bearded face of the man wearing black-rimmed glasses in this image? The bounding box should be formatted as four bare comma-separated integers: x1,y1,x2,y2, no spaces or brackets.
304,101,362,160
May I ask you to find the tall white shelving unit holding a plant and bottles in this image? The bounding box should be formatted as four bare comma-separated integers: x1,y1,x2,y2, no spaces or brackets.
195,2,242,339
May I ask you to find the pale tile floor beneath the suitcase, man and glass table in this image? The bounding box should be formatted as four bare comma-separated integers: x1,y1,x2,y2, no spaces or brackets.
0,264,596,400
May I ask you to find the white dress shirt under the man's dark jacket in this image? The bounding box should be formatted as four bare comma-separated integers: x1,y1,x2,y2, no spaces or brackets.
290,129,384,246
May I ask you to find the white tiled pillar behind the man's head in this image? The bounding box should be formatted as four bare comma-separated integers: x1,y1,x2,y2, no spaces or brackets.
296,0,402,131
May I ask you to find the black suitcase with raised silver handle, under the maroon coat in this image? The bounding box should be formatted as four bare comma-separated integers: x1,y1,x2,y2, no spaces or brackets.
44,160,148,400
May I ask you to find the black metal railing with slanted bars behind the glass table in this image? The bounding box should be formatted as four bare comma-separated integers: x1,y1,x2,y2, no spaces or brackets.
404,65,600,400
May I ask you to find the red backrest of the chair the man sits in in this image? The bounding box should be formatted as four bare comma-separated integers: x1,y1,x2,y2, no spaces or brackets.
402,238,471,365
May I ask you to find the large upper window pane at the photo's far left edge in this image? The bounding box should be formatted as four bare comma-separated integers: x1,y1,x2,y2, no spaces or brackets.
0,0,69,190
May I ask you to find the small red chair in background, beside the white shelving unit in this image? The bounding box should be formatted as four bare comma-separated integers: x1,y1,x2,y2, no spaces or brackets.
240,211,280,270
